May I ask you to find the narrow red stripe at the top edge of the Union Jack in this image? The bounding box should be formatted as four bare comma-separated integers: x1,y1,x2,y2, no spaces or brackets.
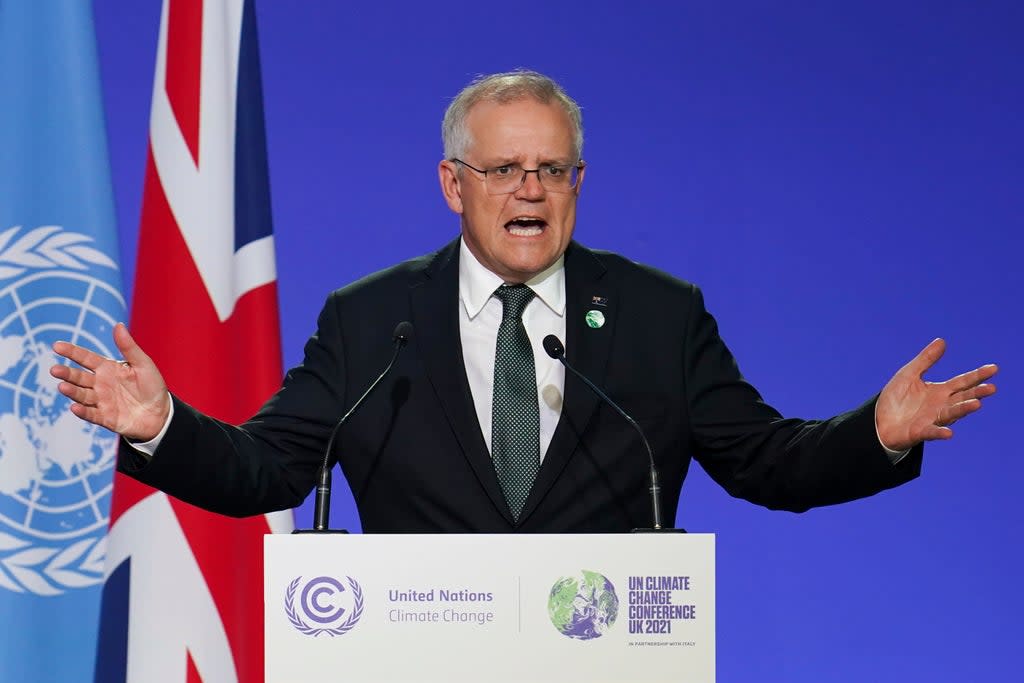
164,0,203,168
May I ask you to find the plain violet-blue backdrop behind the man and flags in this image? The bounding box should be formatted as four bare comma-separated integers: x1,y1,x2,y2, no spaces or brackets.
95,0,1024,682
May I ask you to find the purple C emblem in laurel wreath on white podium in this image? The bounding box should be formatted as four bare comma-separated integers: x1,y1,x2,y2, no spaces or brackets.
285,577,362,637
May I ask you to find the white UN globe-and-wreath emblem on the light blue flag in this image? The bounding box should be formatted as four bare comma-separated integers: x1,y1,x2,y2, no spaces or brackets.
0,225,125,595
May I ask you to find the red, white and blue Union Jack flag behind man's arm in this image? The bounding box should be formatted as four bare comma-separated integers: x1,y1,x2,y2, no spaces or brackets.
96,0,292,683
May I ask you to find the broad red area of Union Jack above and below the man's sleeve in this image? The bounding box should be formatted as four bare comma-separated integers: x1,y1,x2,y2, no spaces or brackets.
123,141,282,683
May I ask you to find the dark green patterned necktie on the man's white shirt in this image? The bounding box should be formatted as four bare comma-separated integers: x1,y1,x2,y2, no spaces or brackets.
490,285,541,520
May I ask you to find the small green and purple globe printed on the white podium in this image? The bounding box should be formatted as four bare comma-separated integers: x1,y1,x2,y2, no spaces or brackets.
548,569,618,640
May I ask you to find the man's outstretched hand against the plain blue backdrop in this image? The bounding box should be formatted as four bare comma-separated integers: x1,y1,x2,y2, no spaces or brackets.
874,339,998,451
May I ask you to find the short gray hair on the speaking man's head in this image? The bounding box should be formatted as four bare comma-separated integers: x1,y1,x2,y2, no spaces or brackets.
441,70,583,160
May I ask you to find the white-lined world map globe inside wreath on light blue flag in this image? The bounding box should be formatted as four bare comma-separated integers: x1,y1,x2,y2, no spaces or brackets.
0,270,125,548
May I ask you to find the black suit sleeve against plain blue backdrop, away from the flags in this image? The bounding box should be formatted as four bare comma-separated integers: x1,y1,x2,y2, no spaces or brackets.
683,288,924,512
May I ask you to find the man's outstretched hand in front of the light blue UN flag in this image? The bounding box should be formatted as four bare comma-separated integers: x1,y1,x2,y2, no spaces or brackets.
50,323,170,441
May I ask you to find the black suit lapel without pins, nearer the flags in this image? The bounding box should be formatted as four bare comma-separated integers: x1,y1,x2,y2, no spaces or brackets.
410,240,512,524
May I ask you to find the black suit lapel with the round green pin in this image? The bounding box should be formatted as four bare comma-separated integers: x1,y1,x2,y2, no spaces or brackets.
519,242,618,524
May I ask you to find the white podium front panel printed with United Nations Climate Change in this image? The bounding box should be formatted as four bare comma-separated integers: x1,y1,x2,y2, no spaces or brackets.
264,533,715,683
